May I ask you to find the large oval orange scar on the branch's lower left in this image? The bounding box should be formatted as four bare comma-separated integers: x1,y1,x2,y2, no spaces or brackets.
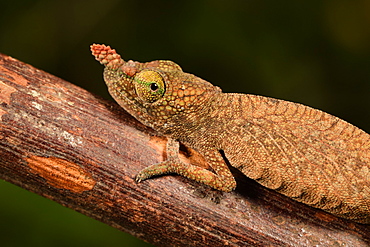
26,156,96,193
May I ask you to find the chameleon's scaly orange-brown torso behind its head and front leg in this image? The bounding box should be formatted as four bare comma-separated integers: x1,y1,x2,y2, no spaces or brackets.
215,94,370,223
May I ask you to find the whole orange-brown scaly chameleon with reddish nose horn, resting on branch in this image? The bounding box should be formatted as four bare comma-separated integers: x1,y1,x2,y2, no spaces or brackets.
90,44,370,224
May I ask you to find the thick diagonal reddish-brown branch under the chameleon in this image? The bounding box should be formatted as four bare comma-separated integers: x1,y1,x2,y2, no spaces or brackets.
0,54,370,246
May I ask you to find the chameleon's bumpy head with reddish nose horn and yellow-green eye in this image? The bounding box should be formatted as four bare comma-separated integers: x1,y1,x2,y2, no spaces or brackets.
91,44,221,132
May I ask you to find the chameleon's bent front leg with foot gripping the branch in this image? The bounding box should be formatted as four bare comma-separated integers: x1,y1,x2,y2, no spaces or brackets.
136,138,236,192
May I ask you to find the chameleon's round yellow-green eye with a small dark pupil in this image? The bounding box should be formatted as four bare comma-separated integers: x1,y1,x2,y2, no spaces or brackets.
133,70,165,103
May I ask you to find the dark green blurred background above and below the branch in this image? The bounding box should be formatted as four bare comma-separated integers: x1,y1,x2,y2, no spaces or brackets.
0,0,370,247
